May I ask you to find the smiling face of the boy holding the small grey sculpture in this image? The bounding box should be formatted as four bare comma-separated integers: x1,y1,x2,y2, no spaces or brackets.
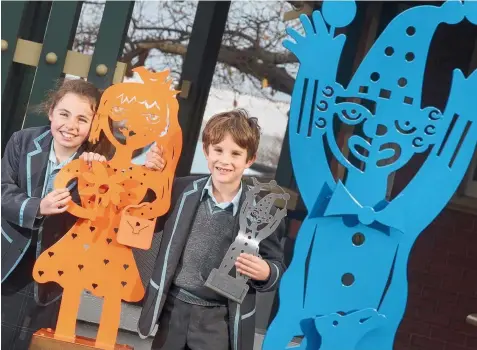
204,133,255,185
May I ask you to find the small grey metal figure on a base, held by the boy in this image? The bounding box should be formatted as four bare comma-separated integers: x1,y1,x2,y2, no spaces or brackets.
205,178,290,304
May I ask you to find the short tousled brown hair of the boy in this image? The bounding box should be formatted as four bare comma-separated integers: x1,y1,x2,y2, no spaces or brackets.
202,109,260,161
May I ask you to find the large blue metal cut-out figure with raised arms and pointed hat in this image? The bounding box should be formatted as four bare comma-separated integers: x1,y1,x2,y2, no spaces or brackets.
264,1,477,350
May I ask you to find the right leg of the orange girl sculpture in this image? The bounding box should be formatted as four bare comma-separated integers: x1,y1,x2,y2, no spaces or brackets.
95,295,121,349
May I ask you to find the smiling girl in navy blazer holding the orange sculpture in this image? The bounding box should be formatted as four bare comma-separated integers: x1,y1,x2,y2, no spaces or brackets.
1,80,105,349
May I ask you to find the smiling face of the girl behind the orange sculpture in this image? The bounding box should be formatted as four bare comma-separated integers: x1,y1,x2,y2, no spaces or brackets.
48,93,94,152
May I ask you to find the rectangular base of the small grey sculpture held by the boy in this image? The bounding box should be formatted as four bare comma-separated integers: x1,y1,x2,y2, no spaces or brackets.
205,269,248,304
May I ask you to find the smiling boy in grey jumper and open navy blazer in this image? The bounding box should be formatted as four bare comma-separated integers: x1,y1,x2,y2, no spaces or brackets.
138,110,285,350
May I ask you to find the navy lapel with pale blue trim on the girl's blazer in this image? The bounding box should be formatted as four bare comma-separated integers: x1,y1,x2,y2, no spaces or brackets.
26,130,53,197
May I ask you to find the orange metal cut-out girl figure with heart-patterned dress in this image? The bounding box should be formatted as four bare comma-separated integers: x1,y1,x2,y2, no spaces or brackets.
33,67,182,349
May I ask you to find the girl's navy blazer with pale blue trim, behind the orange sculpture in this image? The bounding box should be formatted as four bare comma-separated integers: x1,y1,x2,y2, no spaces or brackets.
1,126,81,303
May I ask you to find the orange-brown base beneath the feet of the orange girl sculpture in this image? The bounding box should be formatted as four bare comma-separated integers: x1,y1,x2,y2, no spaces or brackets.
29,328,134,350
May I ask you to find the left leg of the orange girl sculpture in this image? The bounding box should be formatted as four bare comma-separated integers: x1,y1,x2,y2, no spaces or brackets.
55,286,83,342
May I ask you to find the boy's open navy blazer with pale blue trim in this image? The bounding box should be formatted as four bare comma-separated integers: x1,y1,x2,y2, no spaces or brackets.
138,176,285,350
